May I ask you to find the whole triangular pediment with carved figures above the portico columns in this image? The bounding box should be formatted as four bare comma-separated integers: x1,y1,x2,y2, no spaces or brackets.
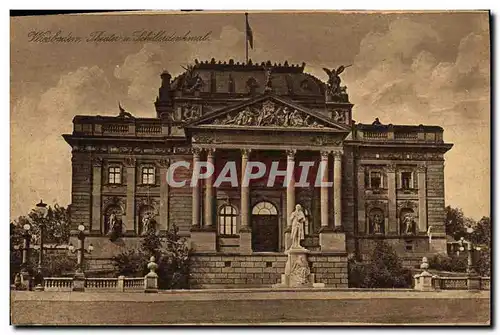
186,95,349,131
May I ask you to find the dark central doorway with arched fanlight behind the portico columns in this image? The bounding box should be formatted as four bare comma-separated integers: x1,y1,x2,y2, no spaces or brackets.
252,201,279,251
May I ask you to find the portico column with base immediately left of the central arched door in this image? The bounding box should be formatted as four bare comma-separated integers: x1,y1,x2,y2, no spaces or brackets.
239,149,252,254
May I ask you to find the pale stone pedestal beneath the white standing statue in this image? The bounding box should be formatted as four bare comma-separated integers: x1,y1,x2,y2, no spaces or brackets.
273,247,325,288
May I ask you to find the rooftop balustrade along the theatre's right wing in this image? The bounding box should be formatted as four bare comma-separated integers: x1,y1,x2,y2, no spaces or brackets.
354,123,444,144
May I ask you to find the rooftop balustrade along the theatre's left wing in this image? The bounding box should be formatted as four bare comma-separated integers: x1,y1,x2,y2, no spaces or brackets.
73,116,169,137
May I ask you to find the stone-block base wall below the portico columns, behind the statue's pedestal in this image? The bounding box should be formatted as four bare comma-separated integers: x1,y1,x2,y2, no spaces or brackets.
190,253,348,288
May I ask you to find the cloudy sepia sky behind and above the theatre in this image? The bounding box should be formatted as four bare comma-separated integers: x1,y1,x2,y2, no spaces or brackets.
10,12,490,219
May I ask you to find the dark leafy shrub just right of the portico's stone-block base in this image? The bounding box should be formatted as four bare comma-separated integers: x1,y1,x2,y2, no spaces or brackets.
349,241,412,288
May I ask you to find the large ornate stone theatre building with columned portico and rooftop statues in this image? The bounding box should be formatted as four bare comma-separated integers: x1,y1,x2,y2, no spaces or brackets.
64,60,452,287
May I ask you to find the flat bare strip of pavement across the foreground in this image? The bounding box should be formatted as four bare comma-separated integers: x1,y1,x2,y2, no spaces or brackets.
11,289,490,325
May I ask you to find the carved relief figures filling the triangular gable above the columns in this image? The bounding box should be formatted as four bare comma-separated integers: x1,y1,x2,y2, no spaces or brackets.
213,101,324,128
